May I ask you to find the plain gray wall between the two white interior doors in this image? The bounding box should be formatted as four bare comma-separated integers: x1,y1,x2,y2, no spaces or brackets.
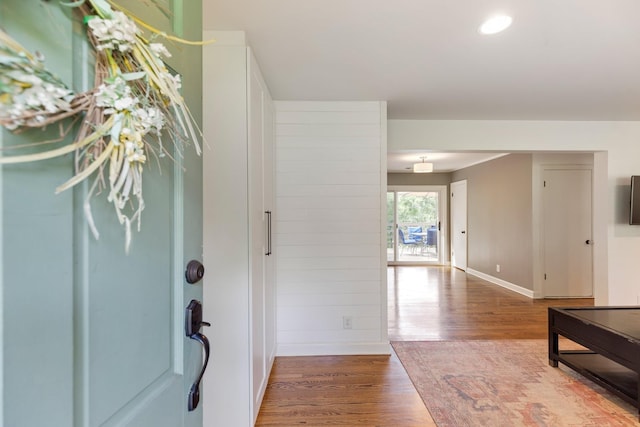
451,154,533,290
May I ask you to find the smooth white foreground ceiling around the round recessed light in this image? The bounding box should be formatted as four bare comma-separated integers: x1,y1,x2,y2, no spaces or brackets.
203,0,640,170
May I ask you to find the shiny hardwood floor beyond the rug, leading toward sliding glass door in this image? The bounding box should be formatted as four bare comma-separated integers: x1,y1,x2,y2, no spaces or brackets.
387,267,593,341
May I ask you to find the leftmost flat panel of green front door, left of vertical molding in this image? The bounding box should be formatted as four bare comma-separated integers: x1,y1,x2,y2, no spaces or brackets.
0,0,74,427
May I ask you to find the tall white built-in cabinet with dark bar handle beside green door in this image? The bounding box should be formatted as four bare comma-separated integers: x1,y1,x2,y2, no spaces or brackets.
204,33,276,426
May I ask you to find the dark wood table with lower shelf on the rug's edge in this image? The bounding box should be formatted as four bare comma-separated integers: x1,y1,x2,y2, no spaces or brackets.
549,307,640,418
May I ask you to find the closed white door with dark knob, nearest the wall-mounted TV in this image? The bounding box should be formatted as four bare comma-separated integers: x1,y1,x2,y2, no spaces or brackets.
543,169,593,298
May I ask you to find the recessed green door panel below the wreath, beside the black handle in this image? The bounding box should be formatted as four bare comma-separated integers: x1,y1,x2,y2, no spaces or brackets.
82,162,179,425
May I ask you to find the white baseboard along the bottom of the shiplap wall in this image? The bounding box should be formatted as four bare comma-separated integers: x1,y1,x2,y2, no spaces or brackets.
276,342,391,356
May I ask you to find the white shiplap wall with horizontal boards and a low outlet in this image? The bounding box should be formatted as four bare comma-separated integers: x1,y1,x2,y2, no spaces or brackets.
275,101,390,356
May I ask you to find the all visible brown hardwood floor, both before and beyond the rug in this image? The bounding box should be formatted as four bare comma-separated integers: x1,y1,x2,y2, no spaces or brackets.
256,267,593,426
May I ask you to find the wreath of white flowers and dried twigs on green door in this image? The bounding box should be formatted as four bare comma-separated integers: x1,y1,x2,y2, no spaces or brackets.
0,0,212,251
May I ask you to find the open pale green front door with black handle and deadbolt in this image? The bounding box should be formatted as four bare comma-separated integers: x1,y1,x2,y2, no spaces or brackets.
0,0,206,427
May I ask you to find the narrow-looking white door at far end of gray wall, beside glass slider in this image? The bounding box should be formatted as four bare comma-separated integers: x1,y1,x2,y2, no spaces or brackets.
450,180,468,271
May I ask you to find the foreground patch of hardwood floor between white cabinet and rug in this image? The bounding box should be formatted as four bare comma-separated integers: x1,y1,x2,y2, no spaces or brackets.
256,355,435,426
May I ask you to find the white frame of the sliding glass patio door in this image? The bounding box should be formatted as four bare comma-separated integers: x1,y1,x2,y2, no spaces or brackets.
383,185,449,266
